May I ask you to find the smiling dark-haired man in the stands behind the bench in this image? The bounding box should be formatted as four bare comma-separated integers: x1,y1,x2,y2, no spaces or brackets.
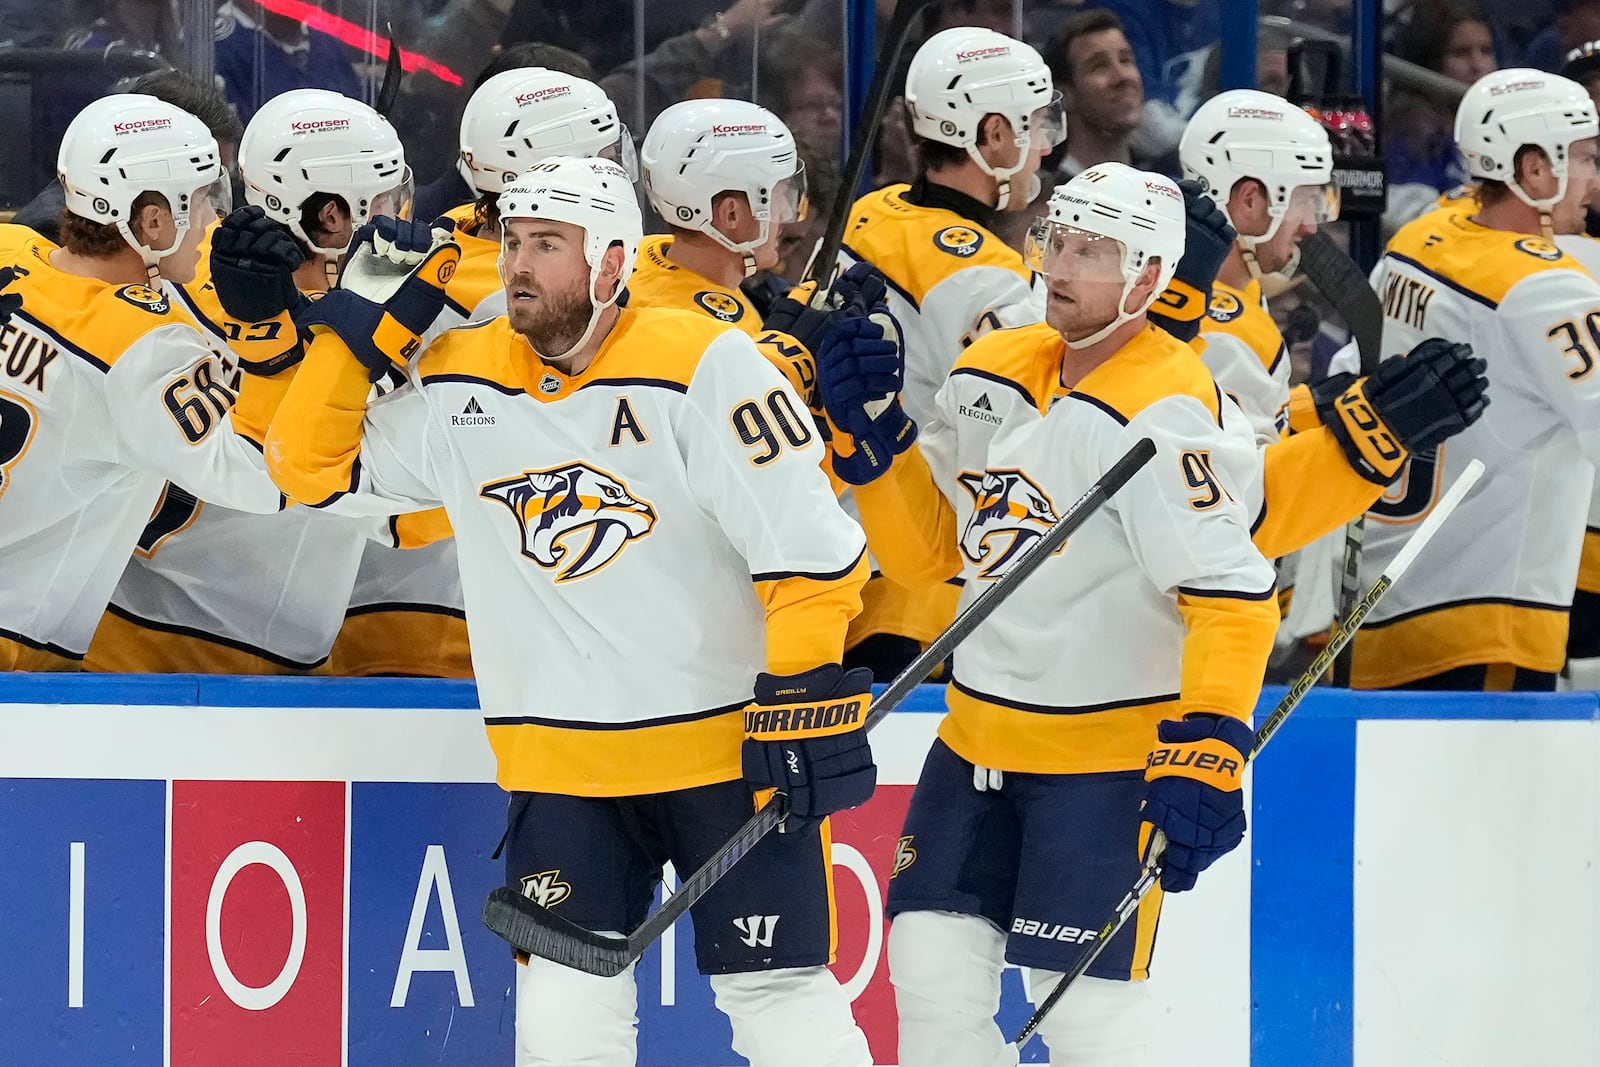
1045,10,1182,179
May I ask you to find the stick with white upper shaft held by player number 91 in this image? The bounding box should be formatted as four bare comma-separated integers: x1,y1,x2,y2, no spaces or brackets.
1011,459,1483,1051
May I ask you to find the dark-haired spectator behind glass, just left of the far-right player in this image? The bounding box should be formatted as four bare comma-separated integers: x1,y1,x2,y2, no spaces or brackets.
1384,0,1501,232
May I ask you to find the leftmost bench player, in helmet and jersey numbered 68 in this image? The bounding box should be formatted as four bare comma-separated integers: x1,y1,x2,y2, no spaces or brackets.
0,94,283,670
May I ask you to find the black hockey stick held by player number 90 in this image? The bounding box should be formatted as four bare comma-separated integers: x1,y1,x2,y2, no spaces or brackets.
483,438,1155,977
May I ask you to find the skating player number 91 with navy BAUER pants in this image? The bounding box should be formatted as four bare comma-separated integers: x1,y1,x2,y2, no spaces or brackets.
824,163,1277,1067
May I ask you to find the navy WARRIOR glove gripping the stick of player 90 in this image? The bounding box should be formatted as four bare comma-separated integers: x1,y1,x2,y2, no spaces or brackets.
742,664,878,830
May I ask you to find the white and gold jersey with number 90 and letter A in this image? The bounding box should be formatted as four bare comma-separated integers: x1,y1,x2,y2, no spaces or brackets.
267,309,866,797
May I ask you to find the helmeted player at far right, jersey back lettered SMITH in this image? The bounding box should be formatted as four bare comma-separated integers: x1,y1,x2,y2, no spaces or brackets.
1352,69,1600,689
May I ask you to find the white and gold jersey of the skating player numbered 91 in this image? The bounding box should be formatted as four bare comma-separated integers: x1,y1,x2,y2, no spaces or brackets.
858,323,1278,774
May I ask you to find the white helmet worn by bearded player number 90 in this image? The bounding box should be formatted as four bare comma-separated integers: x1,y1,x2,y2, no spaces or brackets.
499,155,645,360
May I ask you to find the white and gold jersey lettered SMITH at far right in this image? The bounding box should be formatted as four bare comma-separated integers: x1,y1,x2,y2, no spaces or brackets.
1354,210,1600,688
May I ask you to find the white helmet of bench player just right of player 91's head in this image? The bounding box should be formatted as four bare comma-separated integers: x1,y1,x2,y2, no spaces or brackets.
1178,90,1339,250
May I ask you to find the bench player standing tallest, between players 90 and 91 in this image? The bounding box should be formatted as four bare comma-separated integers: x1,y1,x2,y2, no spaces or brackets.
842,27,1066,677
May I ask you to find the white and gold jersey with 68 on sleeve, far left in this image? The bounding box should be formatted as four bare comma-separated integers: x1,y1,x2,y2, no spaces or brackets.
0,227,285,669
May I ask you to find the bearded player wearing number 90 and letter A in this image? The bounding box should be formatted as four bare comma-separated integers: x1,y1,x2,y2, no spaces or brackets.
267,158,875,1067
